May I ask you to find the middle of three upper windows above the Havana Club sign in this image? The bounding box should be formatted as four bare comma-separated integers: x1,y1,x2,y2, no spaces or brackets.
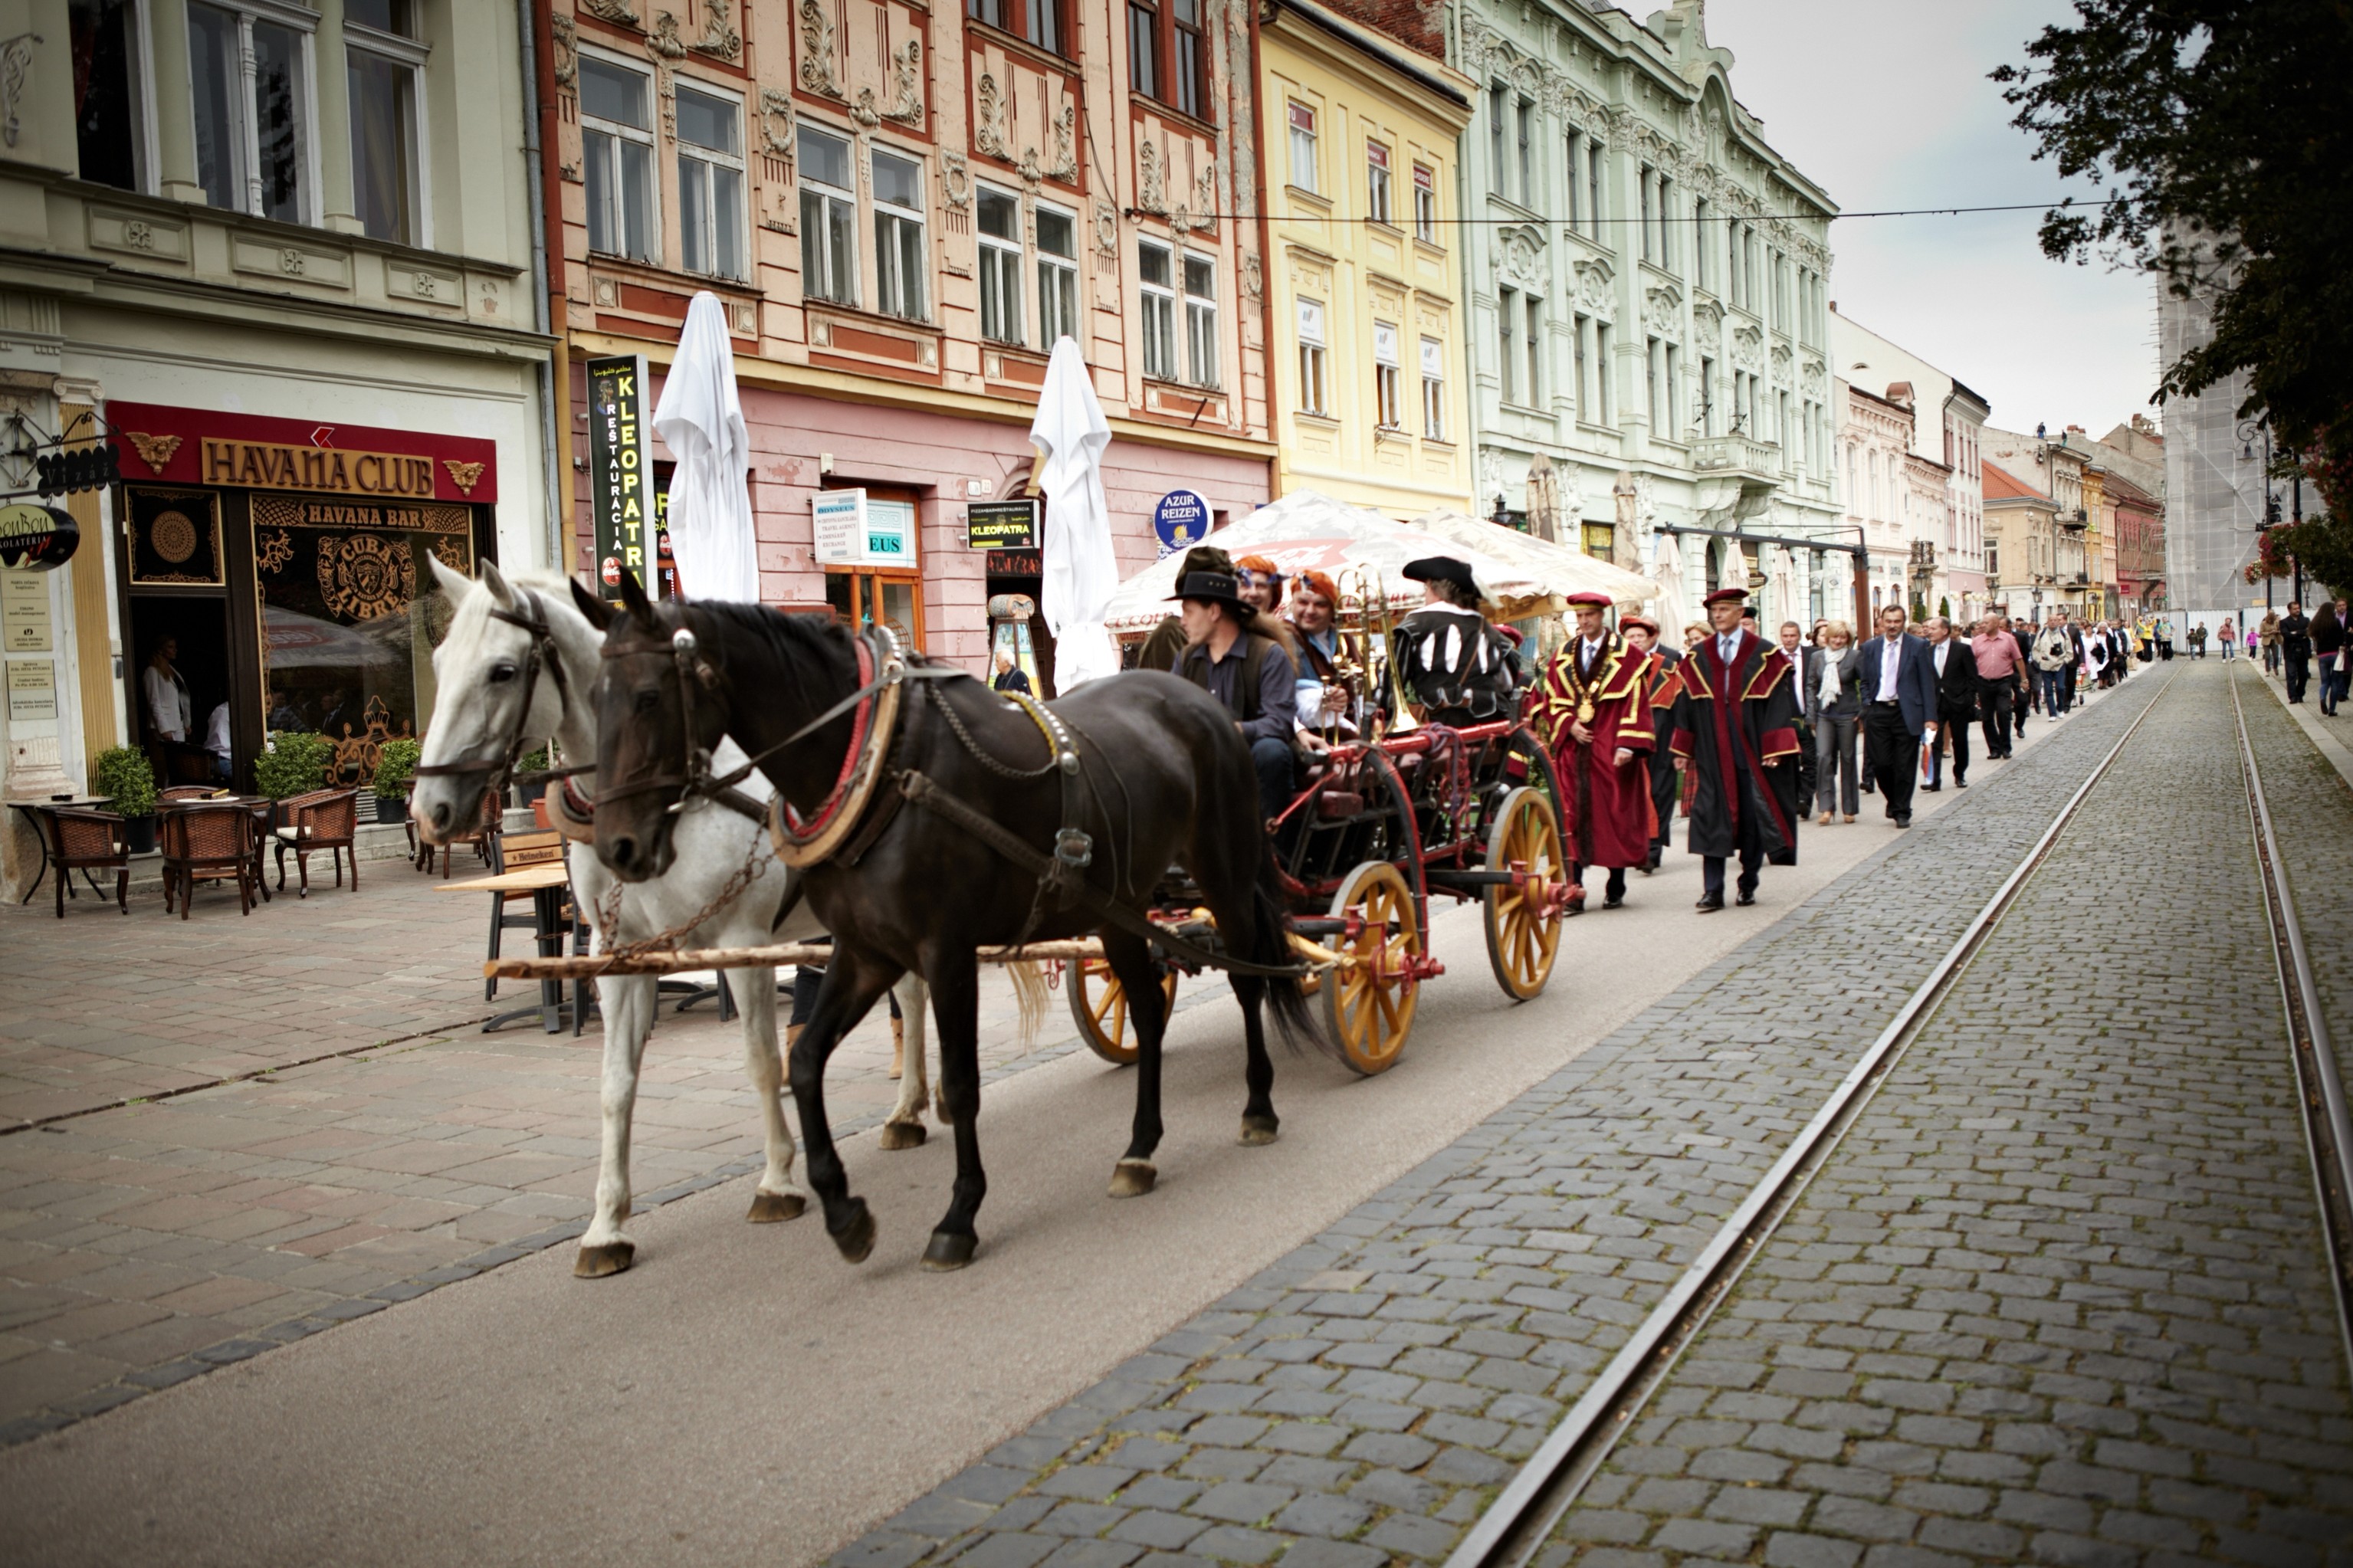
189,0,317,224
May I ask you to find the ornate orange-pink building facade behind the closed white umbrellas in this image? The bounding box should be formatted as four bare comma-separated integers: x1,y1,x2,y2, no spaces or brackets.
543,0,1273,666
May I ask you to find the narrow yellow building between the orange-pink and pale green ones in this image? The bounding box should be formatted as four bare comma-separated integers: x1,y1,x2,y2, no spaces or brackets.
1259,0,1473,518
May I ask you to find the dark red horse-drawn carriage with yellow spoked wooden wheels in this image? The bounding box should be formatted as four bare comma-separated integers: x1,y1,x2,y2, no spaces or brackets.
1068,723,1572,1074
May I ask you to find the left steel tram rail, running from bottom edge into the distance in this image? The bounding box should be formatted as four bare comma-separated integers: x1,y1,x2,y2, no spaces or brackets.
1445,671,2193,1568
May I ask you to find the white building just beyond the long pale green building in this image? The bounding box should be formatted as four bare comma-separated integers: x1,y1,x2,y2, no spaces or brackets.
1830,301,1993,619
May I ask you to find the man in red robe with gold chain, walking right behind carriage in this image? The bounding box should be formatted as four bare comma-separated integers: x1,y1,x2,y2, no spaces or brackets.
1534,593,1656,909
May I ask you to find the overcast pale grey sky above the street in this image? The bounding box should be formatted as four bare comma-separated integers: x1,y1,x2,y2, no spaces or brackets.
1694,0,2160,435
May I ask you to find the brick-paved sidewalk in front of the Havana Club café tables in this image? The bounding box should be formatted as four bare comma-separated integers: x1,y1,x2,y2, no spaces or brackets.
0,861,1078,1445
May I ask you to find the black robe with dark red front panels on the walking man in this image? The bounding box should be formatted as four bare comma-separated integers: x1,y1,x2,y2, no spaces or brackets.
1673,631,1797,867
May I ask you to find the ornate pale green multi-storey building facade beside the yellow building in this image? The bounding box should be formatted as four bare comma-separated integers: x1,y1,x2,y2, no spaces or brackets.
1447,0,1859,622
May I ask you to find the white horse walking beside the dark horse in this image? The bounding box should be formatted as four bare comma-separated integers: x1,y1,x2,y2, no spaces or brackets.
409,560,930,1278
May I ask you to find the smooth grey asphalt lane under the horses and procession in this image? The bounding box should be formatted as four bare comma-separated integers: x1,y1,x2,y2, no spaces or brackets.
0,706,2099,1566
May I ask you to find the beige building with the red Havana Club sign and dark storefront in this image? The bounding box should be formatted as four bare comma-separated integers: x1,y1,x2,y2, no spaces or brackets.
0,0,560,881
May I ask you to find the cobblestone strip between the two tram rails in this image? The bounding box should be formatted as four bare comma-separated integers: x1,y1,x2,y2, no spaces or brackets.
1539,654,2353,1568
